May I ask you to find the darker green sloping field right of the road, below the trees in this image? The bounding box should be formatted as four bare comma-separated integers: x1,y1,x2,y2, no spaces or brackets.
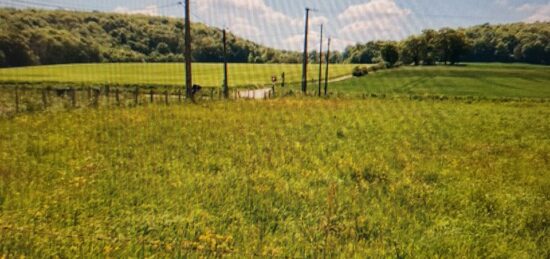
330,64,550,98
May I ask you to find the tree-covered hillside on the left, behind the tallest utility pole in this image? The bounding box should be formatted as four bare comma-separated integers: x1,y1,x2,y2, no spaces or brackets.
0,8,301,67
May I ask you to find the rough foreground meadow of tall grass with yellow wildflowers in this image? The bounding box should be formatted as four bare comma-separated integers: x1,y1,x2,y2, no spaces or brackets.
0,98,550,258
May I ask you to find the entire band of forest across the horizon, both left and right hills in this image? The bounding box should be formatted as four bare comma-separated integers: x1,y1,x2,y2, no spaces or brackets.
0,8,550,67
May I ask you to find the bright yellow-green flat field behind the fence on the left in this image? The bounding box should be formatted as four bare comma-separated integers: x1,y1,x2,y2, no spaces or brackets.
0,63,354,87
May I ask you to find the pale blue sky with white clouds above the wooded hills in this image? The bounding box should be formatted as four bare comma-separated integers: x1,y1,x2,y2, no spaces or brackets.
0,0,550,50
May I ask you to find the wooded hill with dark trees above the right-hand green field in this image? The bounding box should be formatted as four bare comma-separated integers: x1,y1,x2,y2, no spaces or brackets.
340,22,550,65
